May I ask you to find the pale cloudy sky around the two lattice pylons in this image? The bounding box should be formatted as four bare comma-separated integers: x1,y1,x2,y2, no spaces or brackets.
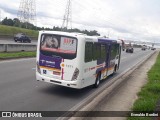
0,0,160,43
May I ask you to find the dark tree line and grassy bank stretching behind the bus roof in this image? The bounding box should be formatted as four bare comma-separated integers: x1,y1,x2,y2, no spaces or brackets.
0,17,100,37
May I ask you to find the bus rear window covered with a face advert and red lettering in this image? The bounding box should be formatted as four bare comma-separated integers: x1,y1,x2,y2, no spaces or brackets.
40,34,77,59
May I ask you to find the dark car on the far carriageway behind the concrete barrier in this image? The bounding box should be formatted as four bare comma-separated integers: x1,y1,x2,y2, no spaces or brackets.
14,33,31,43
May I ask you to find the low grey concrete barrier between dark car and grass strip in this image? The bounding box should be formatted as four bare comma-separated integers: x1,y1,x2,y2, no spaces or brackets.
0,44,37,52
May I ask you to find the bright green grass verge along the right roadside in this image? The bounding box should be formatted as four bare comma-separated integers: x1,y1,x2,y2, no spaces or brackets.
128,53,160,120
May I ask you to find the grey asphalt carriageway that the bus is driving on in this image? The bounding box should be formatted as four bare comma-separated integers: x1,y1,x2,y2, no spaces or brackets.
0,49,153,120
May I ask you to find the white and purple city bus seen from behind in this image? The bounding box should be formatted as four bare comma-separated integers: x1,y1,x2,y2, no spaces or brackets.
36,31,121,89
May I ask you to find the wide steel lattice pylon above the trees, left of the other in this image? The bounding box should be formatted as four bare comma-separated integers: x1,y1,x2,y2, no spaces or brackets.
17,0,36,28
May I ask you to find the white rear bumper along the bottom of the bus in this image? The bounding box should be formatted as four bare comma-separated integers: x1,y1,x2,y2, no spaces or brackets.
36,72,82,89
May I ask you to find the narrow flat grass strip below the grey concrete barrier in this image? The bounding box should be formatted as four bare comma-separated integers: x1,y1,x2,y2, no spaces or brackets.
0,52,36,60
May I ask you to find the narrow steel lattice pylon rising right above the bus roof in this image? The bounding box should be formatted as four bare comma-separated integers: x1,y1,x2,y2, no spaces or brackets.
61,0,72,30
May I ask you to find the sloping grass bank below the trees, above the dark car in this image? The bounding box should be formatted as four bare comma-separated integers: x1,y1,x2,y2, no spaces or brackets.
0,25,38,38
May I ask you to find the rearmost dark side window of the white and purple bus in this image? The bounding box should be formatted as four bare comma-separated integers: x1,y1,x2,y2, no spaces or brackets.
85,42,93,62
